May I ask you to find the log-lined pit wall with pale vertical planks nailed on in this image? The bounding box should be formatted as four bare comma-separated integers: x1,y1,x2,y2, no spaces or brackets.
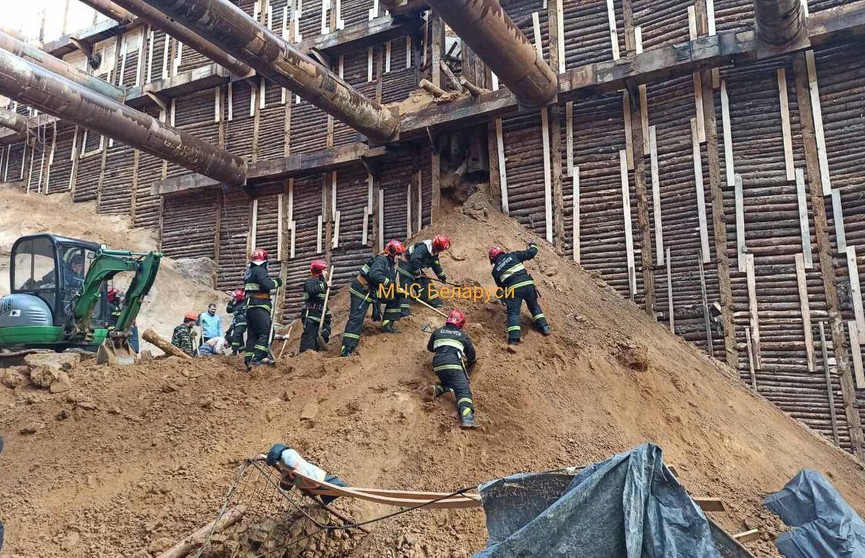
0,0,865,458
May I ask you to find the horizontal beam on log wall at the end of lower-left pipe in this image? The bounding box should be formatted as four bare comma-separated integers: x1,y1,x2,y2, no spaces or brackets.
151,143,388,196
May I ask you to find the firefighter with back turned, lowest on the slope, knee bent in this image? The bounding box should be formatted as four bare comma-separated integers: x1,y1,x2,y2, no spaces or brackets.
427,310,477,428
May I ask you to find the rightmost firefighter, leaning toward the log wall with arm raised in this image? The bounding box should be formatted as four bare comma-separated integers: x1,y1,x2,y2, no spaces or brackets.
489,243,550,345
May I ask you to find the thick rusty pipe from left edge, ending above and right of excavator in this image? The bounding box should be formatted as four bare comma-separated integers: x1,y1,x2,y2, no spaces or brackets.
0,50,246,186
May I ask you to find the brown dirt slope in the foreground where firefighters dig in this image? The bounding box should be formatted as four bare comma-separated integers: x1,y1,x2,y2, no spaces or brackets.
0,195,865,557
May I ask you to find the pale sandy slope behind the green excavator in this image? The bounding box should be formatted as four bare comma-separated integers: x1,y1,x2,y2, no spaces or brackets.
0,186,230,348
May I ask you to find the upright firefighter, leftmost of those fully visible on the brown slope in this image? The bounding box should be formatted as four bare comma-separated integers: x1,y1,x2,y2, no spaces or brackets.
243,248,282,370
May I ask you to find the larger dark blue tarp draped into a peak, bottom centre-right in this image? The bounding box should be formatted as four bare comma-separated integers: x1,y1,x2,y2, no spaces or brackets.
475,444,720,558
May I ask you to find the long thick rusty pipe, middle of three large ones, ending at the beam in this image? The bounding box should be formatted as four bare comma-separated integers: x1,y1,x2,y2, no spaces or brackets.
141,0,399,142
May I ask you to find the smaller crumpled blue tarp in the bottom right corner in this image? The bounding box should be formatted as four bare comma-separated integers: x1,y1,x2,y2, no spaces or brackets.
763,469,865,558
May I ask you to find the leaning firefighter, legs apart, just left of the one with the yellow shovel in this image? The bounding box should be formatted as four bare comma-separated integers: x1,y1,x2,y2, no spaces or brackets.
340,240,405,356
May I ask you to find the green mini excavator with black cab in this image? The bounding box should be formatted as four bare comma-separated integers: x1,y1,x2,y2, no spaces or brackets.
0,234,162,365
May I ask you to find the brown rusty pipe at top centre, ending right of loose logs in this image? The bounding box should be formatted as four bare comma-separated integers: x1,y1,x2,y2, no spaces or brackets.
429,0,558,107
